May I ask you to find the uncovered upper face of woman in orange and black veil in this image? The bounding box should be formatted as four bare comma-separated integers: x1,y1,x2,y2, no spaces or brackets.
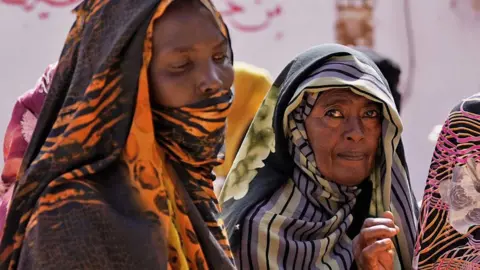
149,1,233,107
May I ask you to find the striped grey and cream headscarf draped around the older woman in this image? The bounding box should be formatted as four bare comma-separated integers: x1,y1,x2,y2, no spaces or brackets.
220,45,418,269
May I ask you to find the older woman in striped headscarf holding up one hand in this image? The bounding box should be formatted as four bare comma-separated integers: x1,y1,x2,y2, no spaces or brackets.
220,45,418,269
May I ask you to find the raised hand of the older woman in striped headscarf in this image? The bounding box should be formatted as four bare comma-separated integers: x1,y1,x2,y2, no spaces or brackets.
353,211,400,270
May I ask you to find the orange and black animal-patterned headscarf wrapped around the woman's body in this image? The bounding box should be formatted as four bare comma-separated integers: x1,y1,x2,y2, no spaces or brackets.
0,0,234,269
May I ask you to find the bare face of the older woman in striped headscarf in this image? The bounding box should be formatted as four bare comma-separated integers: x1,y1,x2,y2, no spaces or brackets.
305,89,382,186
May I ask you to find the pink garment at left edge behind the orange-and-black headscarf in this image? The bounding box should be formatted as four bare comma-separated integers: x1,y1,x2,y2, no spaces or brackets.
0,63,57,239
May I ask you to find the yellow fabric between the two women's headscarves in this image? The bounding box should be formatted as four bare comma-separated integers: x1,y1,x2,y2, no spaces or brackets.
214,62,272,177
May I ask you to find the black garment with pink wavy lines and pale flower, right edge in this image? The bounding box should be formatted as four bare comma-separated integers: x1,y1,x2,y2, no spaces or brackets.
413,94,480,269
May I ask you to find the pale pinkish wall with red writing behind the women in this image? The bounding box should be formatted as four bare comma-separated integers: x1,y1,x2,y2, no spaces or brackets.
0,0,480,199
